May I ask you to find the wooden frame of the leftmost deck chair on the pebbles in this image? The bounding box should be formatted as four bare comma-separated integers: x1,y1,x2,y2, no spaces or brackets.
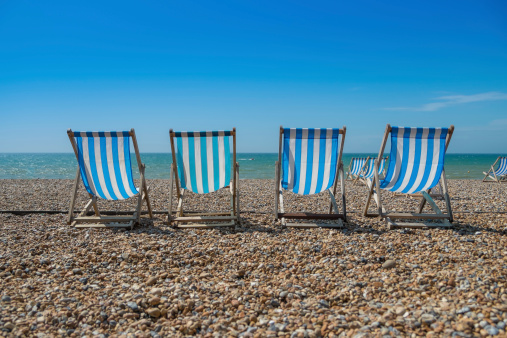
67,128,153,230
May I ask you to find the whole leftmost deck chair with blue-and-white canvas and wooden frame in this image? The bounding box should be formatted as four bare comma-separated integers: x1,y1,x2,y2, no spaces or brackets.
67,129,153,229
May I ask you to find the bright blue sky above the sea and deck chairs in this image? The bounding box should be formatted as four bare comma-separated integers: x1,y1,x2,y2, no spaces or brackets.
0,0,507,154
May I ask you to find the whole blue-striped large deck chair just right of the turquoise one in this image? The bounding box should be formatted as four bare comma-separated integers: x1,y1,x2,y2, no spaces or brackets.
275,127,347,228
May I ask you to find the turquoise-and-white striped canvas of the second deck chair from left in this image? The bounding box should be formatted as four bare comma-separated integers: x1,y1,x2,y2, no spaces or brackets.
174,131,232,194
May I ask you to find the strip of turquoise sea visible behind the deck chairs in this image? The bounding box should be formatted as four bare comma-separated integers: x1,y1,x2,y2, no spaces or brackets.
0,153,505,179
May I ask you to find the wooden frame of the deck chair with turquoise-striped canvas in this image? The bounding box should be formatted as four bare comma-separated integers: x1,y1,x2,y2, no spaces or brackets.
167,128,241,228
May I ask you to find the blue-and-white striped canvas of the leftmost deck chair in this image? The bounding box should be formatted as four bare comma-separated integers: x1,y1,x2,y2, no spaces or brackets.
74,131,138,200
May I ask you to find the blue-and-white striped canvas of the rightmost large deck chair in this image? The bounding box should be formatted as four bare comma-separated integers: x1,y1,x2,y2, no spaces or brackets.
380,127,448,194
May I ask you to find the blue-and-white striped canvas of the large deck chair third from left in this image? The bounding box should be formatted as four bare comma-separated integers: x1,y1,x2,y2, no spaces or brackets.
282,128,340,195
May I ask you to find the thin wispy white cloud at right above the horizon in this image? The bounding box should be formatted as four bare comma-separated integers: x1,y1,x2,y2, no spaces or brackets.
384,92,507,111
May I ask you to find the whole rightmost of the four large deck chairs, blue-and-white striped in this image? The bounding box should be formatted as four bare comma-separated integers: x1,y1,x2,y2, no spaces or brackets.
363,125,454,229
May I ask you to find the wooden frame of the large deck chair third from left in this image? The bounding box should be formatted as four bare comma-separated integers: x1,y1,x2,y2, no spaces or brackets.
274,126,347,228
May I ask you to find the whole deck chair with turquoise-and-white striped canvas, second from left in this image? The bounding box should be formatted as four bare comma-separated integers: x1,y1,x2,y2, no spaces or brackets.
168,128,240,228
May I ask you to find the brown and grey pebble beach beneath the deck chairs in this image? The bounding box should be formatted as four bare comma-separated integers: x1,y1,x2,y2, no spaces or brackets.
0,179,507,337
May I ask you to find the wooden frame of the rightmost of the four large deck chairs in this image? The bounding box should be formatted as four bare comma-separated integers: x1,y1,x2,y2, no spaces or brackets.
363,124,454,229
